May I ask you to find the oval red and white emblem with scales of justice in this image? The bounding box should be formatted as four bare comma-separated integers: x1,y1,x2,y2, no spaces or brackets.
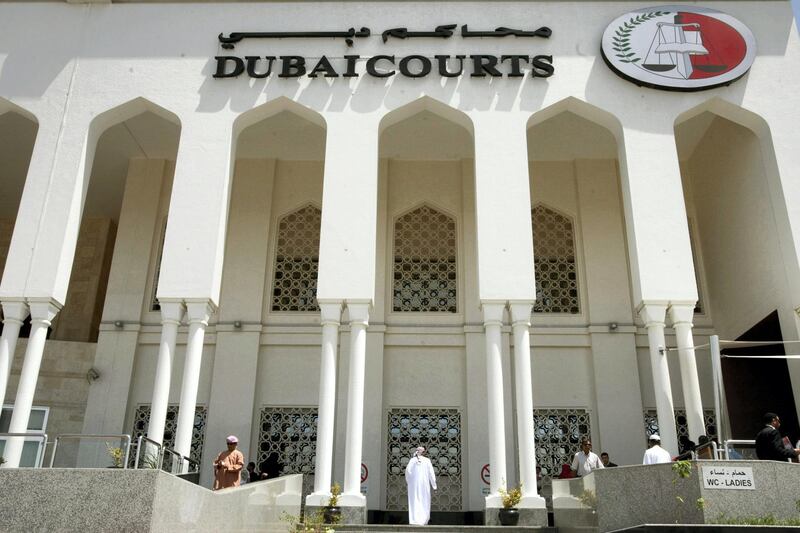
602,5,756,91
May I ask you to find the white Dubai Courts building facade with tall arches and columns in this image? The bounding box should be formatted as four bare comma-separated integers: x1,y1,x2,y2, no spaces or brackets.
0,1,800,511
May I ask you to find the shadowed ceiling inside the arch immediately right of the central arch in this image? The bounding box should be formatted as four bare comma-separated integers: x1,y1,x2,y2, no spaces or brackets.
528,111,617,161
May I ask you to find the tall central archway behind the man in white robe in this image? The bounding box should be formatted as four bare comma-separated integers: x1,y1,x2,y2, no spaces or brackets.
373,97,478,512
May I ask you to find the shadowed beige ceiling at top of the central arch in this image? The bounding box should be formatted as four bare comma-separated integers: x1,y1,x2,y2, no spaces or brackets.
380,110,473,161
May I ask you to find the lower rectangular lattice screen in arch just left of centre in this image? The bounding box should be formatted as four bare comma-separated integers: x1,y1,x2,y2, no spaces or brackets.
255,407,318,502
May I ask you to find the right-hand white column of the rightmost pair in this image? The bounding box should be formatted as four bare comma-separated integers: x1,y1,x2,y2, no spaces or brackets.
669,303,706,442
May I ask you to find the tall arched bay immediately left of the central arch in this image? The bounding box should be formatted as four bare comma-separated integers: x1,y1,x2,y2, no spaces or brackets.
206,98,326,494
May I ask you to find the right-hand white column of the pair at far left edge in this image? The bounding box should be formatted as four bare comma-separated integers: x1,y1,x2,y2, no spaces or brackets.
3,300,60,468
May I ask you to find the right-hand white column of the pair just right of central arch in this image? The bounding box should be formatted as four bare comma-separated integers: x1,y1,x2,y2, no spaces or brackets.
510,303,546,509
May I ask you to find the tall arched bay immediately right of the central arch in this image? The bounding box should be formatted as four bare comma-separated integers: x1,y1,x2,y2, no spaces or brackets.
528,98,654,468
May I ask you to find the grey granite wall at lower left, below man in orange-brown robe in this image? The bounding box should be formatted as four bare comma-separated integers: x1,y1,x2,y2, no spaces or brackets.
0,468,302,533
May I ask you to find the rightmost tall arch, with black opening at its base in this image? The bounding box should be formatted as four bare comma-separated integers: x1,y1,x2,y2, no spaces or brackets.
675,99,800,439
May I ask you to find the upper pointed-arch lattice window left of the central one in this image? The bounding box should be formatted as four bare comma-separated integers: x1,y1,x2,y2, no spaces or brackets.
272,205,322,312
